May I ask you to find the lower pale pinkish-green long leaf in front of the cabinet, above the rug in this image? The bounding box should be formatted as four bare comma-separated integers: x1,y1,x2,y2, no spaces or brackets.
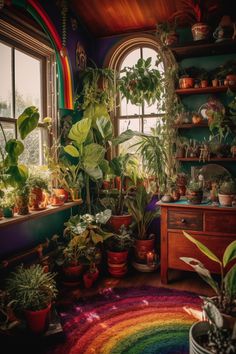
180,257,220,295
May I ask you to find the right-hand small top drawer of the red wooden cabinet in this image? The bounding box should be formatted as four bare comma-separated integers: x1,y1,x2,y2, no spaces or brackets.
205,211,236,236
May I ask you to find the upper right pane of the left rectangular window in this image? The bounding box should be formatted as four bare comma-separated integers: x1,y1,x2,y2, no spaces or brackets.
15,50,42,118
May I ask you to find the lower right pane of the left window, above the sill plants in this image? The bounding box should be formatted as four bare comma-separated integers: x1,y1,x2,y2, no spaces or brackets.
20,128,46,165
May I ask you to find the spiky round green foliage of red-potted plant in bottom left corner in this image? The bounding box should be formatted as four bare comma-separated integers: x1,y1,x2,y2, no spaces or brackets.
6,264,57,311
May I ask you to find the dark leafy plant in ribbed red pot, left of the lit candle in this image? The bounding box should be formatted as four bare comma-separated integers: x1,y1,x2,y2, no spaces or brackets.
105,226,134,277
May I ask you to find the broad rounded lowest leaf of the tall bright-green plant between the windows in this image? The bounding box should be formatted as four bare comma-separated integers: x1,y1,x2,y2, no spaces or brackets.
83,143,105,169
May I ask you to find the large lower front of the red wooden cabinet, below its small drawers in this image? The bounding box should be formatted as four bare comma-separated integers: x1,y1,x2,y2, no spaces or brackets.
168,231,233,273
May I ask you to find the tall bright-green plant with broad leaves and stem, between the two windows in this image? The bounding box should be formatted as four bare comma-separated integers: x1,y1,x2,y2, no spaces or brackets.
64,104,113,214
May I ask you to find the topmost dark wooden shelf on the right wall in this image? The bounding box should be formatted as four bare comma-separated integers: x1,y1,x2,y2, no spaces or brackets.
171,39,236,60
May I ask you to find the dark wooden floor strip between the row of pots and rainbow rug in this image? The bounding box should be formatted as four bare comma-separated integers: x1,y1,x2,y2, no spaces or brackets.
59,270,213,302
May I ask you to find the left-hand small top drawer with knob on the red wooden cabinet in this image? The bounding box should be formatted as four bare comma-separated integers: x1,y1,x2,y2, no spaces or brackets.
168,210,203,231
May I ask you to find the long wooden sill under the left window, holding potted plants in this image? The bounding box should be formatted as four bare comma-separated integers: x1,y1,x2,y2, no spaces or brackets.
0,199,82,228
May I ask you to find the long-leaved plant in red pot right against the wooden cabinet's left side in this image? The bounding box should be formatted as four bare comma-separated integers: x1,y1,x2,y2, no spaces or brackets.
126,186,160,264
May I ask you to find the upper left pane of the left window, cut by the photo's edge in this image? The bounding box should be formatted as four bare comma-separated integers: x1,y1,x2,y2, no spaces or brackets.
0,43,13,117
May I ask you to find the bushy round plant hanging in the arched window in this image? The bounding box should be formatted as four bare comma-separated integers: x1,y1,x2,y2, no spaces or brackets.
117,57,163,105
